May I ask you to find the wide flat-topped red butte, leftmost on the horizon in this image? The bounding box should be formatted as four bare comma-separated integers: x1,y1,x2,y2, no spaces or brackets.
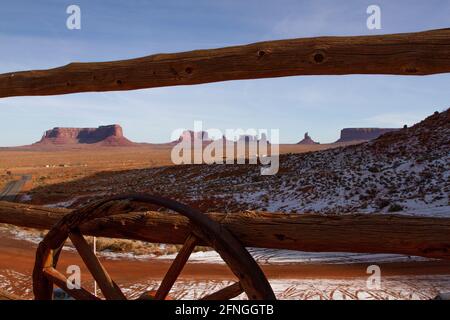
33,124,135,146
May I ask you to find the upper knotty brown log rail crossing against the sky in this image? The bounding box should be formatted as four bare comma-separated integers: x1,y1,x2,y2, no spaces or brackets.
0,29,450,97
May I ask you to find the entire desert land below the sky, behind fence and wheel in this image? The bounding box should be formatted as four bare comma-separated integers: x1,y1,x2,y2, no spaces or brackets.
0,110,450,299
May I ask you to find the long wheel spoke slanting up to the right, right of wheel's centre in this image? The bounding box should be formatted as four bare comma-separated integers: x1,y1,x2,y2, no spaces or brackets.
155,233,198,300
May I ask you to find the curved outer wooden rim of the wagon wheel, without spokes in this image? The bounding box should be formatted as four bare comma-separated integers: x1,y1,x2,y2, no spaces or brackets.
33,193,276,300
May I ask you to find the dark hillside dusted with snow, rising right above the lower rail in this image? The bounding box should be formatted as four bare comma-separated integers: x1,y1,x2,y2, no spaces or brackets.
26,110,450,215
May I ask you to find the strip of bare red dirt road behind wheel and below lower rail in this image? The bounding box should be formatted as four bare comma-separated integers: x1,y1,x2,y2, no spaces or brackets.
0,236,450,296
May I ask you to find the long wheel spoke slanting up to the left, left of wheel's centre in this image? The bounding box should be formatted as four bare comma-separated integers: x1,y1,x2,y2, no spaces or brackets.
69,229,126,300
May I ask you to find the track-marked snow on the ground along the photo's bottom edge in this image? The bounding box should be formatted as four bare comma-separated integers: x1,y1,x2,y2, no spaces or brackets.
0,270,450,300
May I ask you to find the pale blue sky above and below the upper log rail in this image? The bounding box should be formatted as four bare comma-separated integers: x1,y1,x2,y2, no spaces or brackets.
0,0,450,146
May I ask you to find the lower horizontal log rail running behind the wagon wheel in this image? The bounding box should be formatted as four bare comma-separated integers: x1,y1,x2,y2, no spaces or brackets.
0,202,450,259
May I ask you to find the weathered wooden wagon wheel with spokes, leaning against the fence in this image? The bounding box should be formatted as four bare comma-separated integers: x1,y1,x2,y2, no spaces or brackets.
33,194,275,300
